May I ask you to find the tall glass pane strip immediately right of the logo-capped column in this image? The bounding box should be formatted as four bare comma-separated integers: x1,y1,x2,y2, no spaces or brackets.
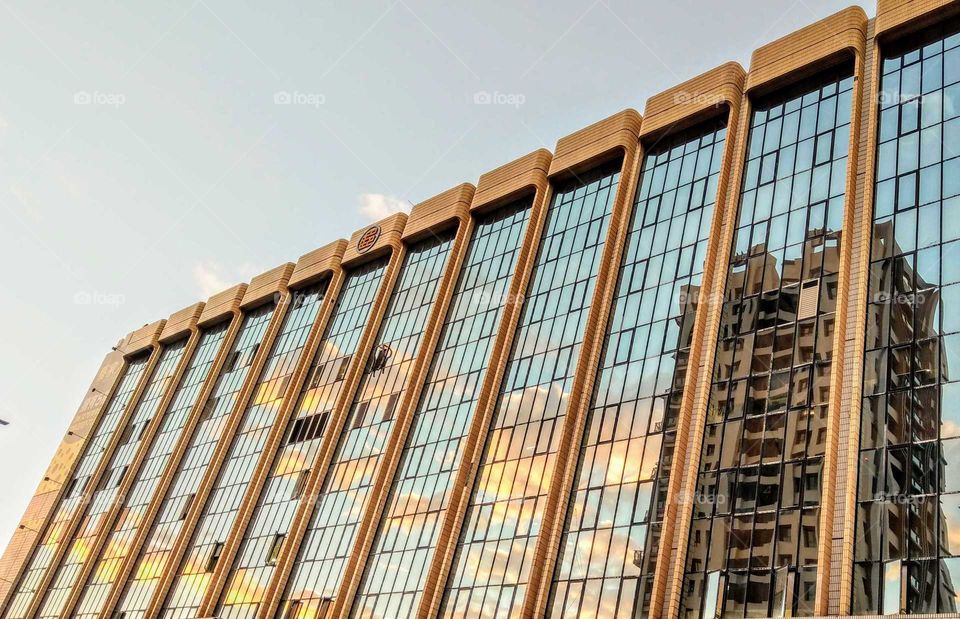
284,233,453,619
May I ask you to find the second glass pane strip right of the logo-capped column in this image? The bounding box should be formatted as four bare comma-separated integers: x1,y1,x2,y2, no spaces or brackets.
354,198,530,617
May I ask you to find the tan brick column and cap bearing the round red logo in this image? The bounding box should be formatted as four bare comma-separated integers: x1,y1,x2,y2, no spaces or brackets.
257,213,407,617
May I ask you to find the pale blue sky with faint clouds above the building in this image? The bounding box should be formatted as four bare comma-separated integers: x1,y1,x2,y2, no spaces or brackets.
0,0,875,543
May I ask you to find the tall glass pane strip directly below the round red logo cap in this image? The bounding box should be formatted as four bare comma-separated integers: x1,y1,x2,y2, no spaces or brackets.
217,260,386,619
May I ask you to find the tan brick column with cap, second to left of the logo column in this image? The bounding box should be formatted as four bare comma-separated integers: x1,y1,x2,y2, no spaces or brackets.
147,263,294,617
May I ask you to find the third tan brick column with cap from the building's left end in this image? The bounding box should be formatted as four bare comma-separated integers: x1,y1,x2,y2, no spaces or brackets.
95,284,247,617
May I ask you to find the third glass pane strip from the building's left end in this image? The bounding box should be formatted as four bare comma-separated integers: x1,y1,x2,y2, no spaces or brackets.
76,323,229,619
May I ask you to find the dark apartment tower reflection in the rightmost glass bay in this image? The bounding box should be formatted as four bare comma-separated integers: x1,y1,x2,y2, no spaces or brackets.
854,219,957,612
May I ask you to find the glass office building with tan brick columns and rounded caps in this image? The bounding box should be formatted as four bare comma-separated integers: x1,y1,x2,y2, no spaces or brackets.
0,0,960,619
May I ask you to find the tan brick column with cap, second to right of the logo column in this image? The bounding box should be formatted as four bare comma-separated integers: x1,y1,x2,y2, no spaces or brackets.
417,149,552,617
